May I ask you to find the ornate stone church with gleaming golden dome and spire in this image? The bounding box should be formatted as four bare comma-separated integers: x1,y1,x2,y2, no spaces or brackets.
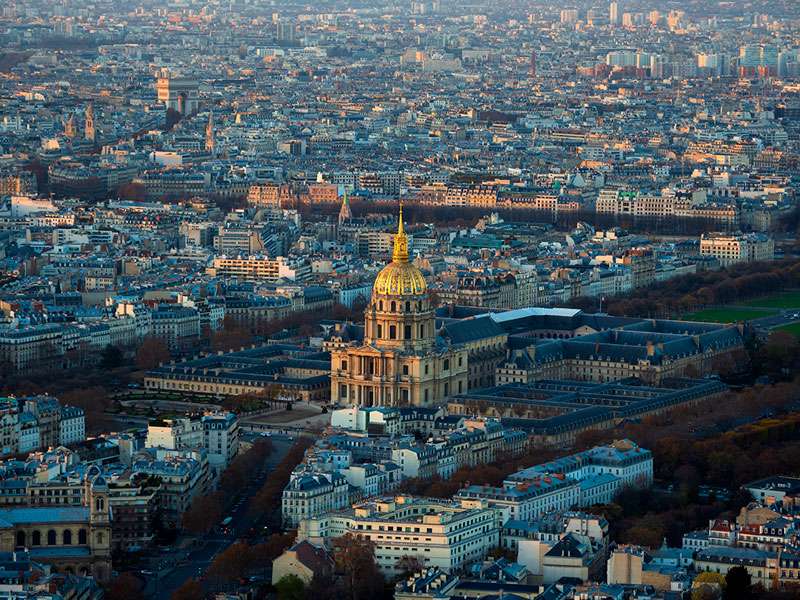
331,207,467,406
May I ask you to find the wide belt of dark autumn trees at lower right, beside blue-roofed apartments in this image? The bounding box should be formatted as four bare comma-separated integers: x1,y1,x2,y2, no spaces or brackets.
578,380,800,547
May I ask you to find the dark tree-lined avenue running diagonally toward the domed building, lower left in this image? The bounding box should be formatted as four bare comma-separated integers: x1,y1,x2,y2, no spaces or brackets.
146,434,293,600
